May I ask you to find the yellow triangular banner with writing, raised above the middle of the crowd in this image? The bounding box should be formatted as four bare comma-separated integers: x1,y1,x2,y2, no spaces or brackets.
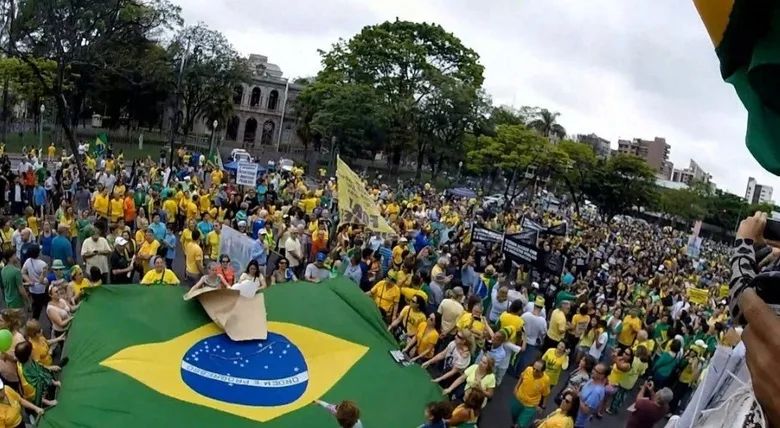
336,157,396,235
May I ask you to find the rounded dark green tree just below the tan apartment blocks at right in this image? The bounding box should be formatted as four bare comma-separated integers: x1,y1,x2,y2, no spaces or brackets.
584,154,657,219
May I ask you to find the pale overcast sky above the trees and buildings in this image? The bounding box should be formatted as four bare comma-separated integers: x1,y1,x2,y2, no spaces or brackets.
174,0,780,196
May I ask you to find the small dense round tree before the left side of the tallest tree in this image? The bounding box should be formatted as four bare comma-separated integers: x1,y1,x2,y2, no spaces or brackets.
310,84,388,157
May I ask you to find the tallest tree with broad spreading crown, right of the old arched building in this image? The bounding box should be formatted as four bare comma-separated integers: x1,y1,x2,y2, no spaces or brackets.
317,20,484,172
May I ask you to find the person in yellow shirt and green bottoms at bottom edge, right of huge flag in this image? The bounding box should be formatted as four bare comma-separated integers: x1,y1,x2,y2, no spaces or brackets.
512,360,550,427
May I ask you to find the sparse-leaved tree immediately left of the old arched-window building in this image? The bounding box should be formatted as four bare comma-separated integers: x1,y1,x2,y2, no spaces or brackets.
174,24,251,136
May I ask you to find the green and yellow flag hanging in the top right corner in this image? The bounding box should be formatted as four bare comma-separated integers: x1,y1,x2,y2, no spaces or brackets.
693,0,780,175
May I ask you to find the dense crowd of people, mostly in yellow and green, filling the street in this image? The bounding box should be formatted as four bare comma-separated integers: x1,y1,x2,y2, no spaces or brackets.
0,139,739,428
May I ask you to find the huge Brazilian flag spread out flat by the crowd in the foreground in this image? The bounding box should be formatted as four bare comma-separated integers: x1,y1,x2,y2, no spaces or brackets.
38,278,441,428
